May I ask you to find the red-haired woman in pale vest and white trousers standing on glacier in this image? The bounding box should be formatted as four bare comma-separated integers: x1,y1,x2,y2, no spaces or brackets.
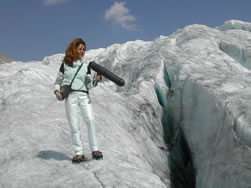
55,38,103,163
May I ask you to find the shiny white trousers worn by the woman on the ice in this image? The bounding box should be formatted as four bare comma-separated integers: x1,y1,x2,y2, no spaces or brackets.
65,92,99,155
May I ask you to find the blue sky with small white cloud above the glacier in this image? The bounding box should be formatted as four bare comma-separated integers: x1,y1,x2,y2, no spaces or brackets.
0,0,251,61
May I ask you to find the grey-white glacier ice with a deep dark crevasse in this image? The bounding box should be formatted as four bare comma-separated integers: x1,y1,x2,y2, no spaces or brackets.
0,20,251,188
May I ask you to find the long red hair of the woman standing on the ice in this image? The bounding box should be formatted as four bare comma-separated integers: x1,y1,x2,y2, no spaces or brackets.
64,38,86,67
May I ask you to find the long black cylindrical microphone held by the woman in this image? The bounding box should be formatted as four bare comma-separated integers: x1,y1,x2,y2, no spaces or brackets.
89,61,125,86
